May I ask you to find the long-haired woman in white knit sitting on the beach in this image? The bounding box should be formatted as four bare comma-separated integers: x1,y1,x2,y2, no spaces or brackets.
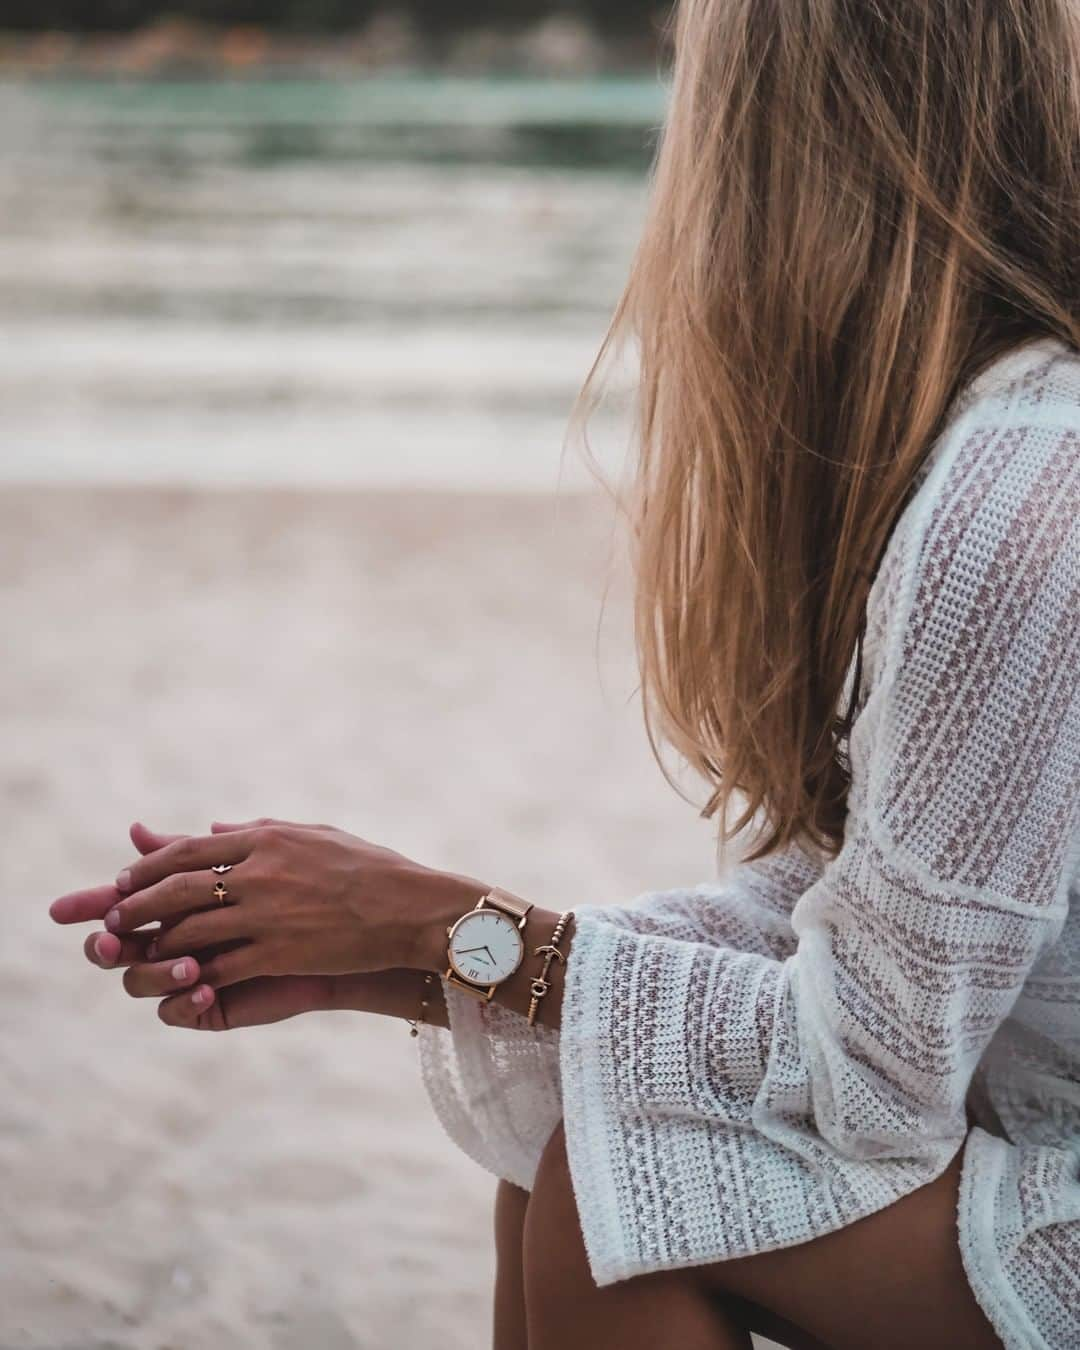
53,0,1080,1350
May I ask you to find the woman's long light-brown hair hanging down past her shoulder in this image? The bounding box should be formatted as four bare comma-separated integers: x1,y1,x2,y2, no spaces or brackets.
583,0,1080,859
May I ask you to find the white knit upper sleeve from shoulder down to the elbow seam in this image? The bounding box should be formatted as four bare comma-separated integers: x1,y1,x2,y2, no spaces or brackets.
867,344,1080,898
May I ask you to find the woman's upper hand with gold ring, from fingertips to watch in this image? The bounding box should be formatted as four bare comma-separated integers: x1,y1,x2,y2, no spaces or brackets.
51,822,487,988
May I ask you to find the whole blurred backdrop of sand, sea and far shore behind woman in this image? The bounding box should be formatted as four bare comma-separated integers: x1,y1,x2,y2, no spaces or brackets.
0,10,766,1350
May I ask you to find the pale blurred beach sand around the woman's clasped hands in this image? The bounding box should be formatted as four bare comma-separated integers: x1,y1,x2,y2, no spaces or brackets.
0,489,783,1350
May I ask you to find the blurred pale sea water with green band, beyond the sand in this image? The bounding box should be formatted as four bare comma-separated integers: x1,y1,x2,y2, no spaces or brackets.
0,77,664,491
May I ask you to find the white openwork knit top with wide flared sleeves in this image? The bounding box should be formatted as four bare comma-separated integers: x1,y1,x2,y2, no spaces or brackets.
421,339,1080,1350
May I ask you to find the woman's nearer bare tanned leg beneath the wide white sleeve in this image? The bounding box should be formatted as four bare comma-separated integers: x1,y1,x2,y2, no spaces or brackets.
524,1126,1002,1350
